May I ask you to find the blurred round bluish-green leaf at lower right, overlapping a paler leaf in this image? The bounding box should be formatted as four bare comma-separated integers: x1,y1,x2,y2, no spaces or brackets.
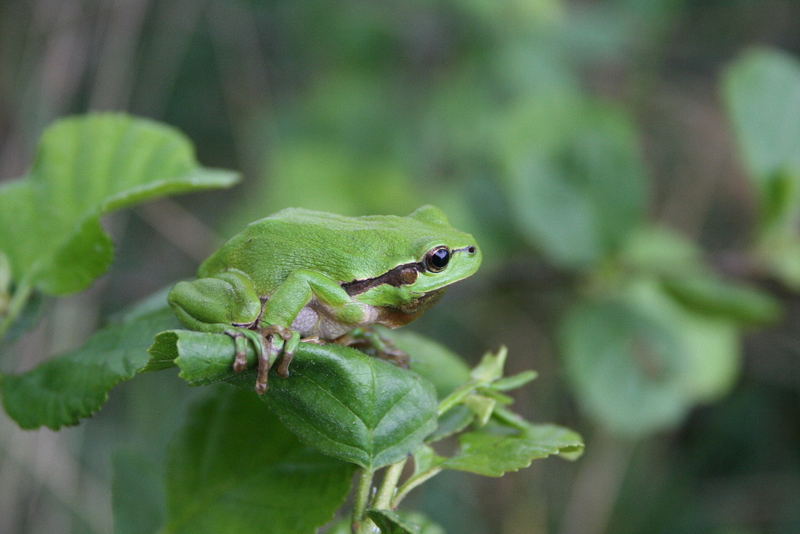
561,301,688,435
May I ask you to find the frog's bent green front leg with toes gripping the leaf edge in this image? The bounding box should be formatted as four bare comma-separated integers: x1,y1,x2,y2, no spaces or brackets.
261,269,366,377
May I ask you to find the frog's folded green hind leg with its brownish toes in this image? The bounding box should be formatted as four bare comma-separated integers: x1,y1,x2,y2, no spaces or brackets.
167,270,270,393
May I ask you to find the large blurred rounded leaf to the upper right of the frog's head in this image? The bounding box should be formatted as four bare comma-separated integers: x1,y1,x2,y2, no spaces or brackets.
504,97,647,268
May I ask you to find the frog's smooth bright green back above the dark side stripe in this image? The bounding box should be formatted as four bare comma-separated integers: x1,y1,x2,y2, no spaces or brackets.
198,208,460,295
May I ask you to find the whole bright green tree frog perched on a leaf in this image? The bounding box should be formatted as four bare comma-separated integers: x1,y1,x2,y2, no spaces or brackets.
168,206,481,394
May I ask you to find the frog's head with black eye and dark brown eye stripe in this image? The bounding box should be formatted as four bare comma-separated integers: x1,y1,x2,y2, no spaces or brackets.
344,206,482,311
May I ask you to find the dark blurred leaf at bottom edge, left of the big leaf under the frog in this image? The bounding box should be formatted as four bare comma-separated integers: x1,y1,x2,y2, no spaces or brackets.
111,451,166,534
